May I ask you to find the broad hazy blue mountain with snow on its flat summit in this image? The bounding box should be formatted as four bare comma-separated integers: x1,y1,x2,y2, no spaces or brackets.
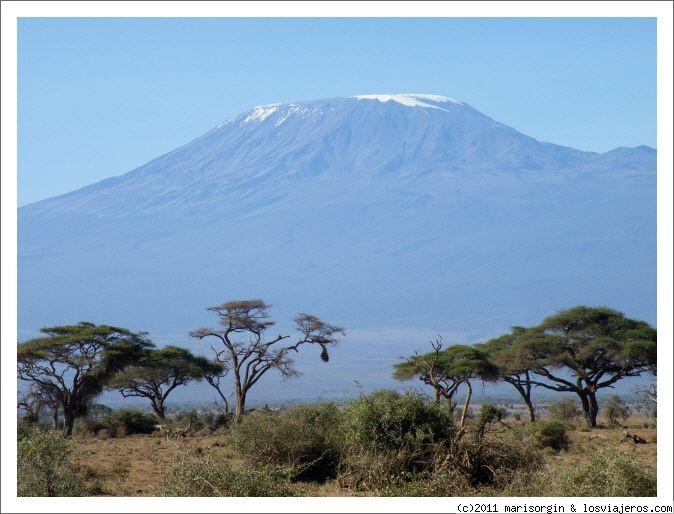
18,94,656,400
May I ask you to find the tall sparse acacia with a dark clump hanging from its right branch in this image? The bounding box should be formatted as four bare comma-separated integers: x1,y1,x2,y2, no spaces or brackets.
190,300,344,422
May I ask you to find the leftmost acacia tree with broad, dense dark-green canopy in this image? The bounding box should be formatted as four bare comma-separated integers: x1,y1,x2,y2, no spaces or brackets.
17,322,152,437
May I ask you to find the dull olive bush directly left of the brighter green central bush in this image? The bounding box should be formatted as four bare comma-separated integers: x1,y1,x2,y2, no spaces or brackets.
233,403,341,482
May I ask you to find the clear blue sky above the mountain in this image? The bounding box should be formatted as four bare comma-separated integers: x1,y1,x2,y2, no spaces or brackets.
18,18,656,205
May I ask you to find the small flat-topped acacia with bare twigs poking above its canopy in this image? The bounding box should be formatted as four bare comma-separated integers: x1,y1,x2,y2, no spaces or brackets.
393,338,498,428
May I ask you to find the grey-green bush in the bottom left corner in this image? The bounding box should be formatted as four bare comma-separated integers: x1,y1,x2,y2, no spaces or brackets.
17,422,85,496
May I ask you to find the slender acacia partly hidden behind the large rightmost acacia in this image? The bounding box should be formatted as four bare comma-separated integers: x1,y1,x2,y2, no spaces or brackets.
476,327,536,422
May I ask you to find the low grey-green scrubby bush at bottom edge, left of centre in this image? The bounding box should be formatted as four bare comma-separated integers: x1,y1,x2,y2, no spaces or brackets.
159,446,298,496
